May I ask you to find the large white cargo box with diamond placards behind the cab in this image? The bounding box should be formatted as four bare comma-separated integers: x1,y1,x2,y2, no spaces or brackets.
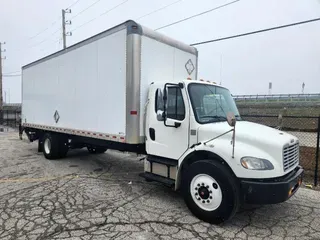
22,21,197,144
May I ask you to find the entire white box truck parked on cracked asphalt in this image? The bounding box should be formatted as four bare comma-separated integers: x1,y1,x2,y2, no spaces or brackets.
21,21,303,223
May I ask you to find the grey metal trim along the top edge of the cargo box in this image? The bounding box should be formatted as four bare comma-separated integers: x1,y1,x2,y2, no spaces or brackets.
22,20,198,69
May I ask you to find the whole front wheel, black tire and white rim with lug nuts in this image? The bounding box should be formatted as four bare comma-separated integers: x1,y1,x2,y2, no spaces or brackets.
183,160,240,224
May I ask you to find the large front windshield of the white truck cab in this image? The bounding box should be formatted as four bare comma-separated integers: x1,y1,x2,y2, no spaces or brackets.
188,83,241,124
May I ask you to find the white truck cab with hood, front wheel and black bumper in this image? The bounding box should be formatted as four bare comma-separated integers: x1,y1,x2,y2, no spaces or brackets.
142,79,303,223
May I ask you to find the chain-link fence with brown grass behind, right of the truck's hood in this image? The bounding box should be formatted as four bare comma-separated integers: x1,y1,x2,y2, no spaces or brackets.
241,114,320,186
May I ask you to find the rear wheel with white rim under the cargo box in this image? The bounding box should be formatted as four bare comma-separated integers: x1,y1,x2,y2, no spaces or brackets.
42,133,69,160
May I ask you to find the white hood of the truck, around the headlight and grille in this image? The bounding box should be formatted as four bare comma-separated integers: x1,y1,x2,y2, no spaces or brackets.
198,121,298,177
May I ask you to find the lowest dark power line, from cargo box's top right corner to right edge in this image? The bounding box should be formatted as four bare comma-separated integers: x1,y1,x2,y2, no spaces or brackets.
191,18,320,46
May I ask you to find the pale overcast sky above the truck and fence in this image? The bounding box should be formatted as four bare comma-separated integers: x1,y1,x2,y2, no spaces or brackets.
0,0,320,102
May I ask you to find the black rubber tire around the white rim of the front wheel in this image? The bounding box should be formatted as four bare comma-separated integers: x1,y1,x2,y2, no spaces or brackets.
183,160,240,224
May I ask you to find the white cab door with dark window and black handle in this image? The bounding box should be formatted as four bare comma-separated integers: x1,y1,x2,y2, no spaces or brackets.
146,84,189,160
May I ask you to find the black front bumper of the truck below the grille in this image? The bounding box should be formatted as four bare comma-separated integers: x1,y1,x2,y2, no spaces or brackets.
241,166,304,204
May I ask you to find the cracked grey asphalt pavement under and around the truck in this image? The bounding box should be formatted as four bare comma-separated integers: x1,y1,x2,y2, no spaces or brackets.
0,132,320,240
